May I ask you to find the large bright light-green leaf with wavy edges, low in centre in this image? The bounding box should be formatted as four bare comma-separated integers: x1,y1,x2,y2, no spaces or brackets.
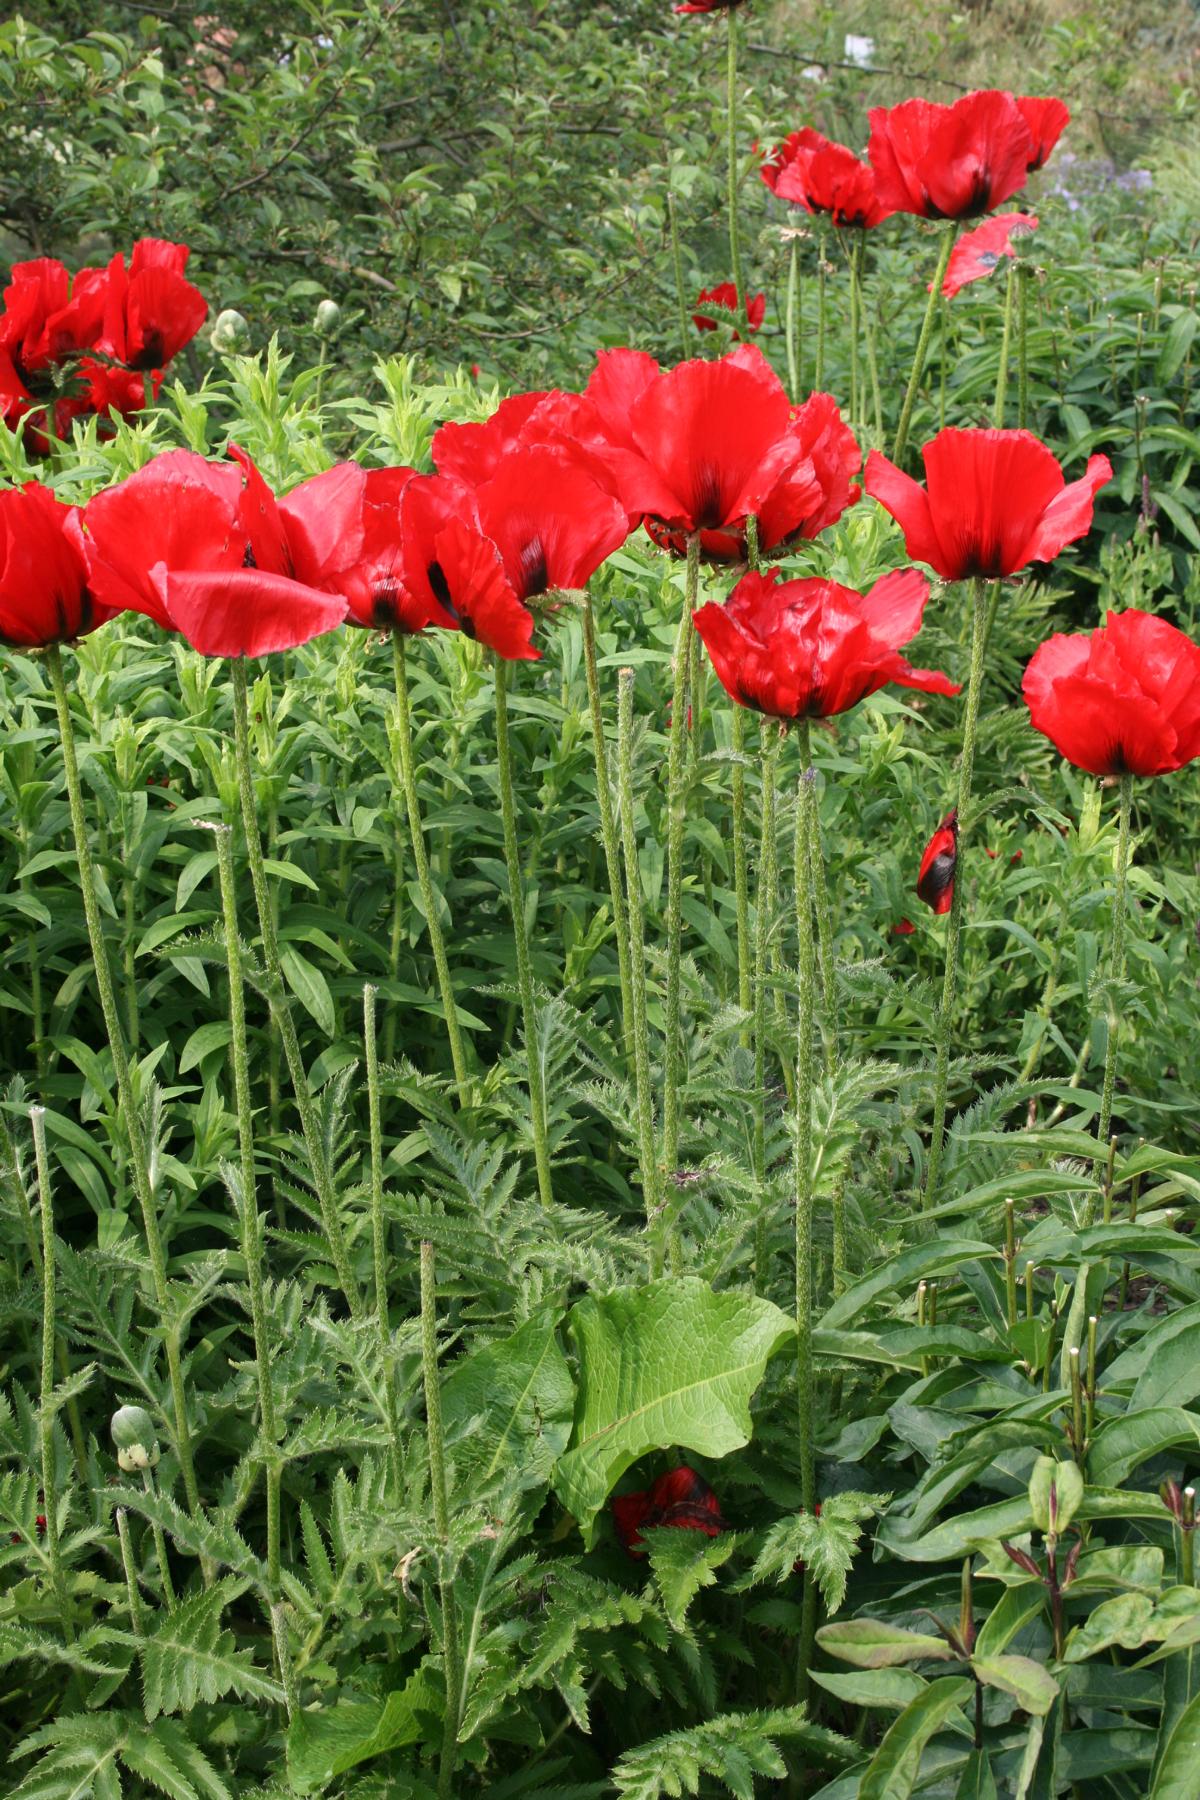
554,1276,795,1544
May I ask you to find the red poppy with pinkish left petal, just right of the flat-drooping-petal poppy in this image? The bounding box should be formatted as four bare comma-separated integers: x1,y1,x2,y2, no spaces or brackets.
279,463,457,632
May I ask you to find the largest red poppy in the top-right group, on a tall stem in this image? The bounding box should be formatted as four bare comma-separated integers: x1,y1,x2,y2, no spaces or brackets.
867,88,1033,220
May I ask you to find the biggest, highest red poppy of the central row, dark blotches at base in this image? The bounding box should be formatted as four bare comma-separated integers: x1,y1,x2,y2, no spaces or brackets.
585,344,858,562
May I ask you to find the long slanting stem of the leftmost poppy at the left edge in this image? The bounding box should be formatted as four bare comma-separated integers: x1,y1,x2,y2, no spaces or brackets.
45,644,200,1517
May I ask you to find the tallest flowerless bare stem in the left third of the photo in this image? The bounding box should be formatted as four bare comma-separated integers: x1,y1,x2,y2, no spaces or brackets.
216,824,282,1602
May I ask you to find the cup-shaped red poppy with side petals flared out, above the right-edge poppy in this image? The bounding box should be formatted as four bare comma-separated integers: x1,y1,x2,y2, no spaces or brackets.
864,427,1112,581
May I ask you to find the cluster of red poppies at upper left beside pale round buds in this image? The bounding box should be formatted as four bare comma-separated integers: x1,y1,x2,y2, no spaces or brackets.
0,238,209,450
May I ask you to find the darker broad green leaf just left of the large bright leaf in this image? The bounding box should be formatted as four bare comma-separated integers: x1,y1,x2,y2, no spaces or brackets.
443,1314,576,1487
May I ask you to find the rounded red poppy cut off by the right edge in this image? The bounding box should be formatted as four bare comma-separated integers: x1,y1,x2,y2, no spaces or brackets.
1022,607,1200,776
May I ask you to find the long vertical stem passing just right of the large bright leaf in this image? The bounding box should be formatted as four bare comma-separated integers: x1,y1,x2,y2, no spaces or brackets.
795,720,817,1697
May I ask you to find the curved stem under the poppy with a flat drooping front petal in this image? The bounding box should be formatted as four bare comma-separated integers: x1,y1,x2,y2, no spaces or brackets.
230,657,362,1318
